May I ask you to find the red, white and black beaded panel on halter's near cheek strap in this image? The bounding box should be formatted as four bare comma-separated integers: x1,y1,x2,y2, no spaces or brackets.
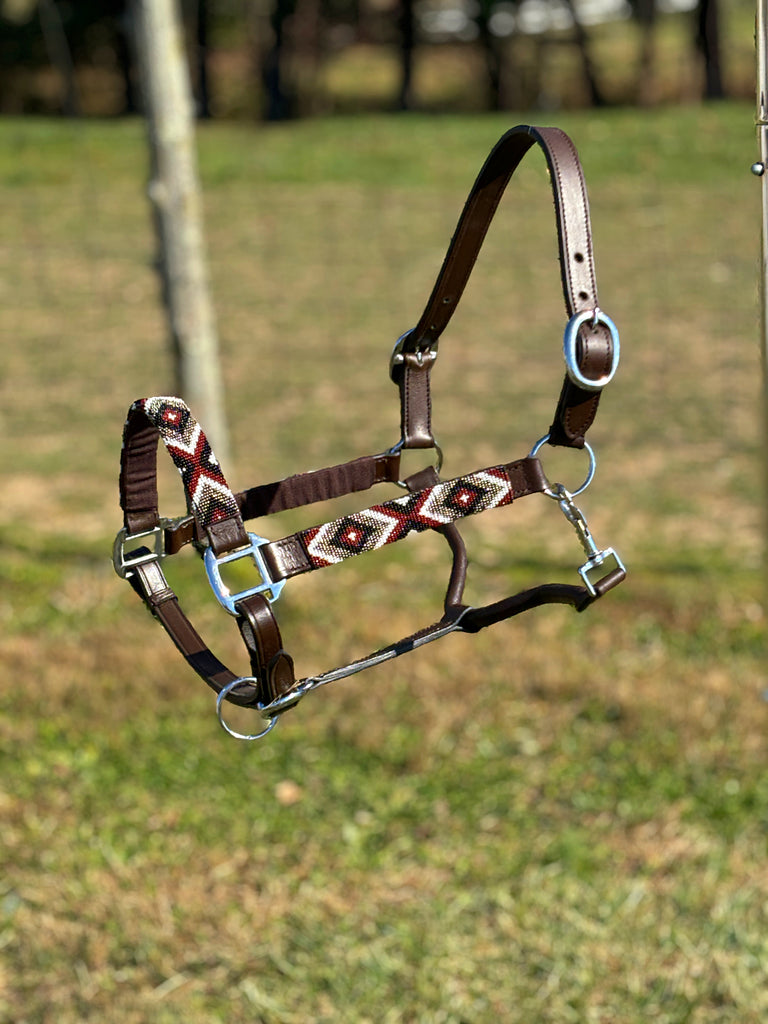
299,466,515,568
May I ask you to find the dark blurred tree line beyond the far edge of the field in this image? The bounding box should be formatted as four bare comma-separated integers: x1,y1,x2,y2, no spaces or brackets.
0,0,755,120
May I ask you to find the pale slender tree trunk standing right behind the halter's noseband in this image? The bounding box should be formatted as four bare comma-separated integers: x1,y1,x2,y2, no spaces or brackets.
134,0,228,460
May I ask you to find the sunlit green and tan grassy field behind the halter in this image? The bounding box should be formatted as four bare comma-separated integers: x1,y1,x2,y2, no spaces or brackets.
0,104,768,1024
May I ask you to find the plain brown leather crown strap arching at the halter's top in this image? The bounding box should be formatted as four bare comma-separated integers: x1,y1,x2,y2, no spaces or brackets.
392,125,612,447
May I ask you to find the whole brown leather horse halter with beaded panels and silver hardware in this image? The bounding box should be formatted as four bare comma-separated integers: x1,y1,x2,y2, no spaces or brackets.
114,125,626,739
